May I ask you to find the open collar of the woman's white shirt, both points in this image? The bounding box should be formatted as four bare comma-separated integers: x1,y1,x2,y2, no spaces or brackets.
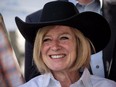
43,68,92,87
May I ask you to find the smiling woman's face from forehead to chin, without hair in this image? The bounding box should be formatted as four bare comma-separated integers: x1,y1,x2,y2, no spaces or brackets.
41,26,76,71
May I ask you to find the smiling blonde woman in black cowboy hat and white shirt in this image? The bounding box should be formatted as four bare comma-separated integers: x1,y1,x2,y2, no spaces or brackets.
15,1,116,87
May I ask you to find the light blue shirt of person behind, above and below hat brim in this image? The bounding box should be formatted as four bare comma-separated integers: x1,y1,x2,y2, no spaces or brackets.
69,0,105,77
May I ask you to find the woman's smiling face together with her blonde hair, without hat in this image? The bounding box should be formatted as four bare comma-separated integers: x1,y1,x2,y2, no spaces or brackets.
34,25,91,74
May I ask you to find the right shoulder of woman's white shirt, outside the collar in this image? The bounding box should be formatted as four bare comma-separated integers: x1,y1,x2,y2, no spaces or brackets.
91,75,116,87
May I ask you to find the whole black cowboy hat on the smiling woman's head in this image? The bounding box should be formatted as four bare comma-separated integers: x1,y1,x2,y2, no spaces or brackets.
15,1,111,52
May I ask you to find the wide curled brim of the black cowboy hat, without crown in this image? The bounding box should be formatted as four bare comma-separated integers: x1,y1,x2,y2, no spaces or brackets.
15,12,111,52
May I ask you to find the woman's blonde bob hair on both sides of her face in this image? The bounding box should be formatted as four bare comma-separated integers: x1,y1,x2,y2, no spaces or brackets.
33,26,94,74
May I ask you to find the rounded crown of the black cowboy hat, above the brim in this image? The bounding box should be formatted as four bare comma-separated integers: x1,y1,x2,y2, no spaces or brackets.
40,1,79,22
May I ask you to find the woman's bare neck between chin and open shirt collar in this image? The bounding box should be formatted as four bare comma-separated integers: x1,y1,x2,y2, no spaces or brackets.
53,72,80,87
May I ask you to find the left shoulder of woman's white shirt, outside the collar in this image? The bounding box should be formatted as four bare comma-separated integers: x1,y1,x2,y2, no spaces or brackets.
19,74,49,87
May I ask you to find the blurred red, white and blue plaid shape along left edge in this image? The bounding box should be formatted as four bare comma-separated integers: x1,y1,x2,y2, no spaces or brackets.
0,14,25,87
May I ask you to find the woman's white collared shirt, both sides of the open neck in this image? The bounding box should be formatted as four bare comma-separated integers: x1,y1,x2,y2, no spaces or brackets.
19,68,116,87
